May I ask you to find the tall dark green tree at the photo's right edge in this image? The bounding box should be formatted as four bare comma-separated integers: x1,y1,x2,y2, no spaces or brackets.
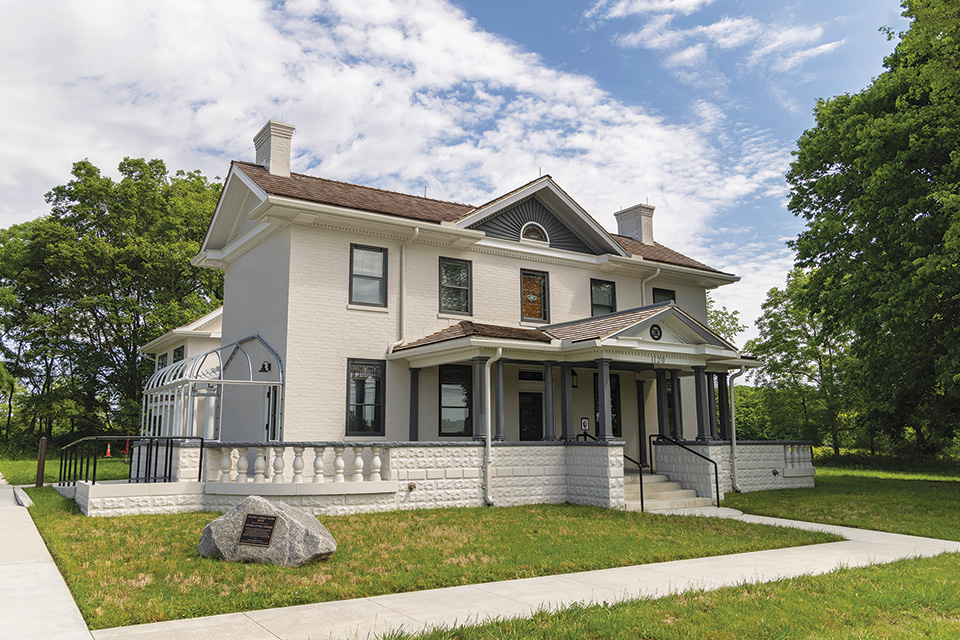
787,0,960,454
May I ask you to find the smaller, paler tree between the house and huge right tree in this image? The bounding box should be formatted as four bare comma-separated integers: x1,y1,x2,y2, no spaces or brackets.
746,269,851,453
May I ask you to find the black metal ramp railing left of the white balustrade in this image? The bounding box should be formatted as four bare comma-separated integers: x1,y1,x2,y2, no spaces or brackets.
57,436,203,487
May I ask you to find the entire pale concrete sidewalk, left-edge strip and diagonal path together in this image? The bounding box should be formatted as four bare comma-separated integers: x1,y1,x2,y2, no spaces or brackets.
7,479,960,640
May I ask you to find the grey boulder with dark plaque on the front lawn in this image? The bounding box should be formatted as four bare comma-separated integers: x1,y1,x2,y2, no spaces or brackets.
197,496,337,567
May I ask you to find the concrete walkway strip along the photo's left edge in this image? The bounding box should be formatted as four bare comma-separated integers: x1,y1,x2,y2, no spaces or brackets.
0,476,91,640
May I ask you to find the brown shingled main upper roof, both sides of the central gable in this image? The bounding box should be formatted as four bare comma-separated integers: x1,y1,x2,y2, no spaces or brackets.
233,160,723,273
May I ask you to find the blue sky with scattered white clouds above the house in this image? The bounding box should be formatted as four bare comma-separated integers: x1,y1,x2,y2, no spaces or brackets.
0,0,906,342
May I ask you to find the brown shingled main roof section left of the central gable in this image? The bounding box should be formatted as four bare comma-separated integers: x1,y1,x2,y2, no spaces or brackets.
233,161,473,222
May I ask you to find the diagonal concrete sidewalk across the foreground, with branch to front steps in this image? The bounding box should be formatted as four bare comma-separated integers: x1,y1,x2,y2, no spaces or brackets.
93,510,960,640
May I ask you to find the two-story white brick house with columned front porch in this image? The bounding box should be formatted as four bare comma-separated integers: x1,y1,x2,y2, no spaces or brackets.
118,121,812,520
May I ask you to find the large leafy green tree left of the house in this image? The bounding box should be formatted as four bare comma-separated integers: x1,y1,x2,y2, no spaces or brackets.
0,158,223,444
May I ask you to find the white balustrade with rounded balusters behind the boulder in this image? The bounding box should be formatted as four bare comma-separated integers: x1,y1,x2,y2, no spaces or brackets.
211,444,389,484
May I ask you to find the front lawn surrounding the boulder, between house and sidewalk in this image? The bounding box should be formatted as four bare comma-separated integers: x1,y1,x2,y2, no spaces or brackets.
22,487,835,629
